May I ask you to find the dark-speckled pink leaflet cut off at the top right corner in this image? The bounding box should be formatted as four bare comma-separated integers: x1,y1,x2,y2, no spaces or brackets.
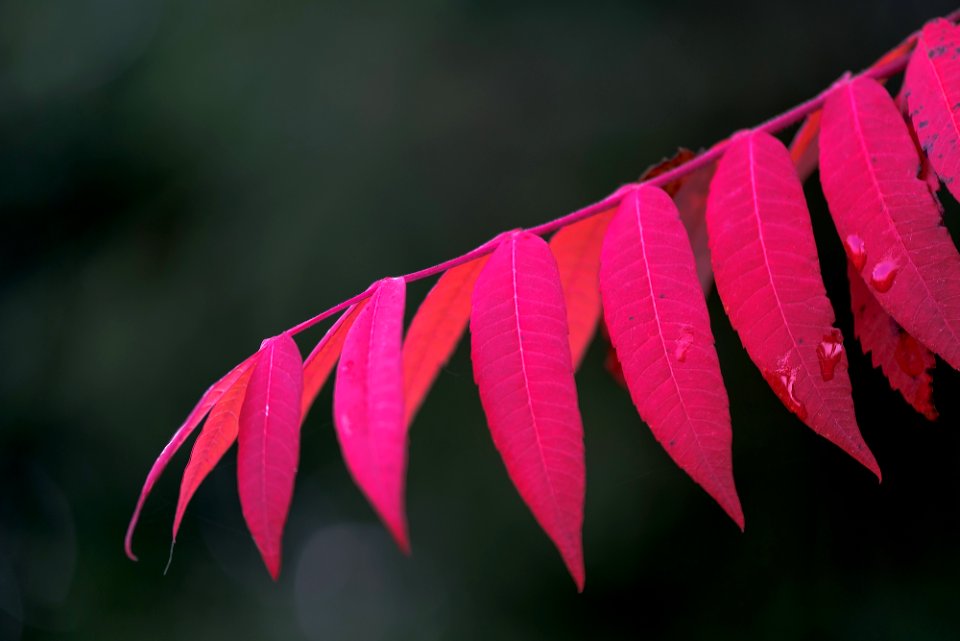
904,19,960,199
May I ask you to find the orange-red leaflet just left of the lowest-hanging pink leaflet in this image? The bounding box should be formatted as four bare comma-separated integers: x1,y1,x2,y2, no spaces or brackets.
403,256,487,425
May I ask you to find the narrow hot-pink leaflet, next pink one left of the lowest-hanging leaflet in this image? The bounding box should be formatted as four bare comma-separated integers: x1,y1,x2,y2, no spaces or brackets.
333,278,410,553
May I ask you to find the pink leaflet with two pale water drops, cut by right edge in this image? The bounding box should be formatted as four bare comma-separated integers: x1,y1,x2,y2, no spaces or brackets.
820,78,960,368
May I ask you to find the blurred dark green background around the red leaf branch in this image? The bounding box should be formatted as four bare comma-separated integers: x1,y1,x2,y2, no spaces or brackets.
0,0,960,640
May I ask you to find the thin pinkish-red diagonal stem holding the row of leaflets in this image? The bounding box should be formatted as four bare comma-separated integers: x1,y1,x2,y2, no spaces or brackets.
286,9,960,334
